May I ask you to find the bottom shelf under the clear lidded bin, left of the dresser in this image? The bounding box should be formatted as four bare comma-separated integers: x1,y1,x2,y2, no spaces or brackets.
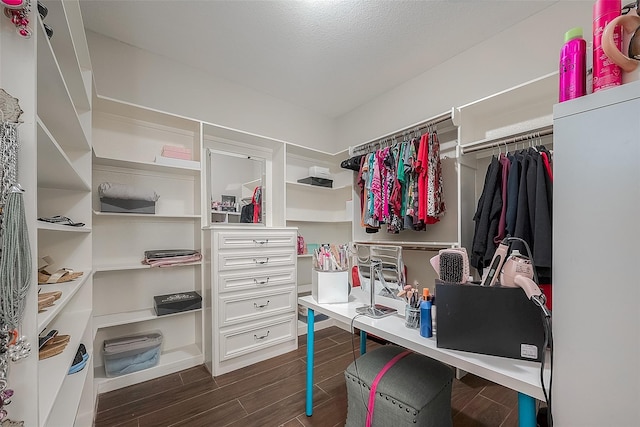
94,344,203,393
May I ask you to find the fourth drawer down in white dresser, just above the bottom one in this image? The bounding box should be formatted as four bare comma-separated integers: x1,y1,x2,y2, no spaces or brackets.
218,286,297,326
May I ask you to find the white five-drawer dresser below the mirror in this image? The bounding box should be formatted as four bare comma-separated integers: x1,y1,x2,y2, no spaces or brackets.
211,226,298,376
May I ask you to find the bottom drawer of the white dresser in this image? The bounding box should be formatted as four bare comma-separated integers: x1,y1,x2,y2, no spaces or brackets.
218,313,298,361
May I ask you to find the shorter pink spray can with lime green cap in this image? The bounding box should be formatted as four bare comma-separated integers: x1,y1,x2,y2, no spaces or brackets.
558,27,587,102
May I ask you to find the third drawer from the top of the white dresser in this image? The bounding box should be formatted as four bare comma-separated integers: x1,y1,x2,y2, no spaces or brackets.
218,267,296,293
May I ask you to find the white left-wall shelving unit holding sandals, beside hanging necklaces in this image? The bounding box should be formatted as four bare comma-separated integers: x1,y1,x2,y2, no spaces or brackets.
0,0,94,427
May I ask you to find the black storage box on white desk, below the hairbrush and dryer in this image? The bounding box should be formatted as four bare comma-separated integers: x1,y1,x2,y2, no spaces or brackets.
435,280,544,361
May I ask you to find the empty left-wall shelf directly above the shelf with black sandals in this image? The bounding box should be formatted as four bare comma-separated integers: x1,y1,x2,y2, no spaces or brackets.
36,118,91,191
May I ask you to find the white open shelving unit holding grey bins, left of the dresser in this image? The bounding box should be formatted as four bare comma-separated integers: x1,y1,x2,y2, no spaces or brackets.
92,99,204,392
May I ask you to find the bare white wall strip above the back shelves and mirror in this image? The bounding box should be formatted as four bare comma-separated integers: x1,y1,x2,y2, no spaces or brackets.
87,31,335,148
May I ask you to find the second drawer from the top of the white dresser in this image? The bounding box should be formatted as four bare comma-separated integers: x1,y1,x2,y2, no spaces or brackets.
217,247,297,271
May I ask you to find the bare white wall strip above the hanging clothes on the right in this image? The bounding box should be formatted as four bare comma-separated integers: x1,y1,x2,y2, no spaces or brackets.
333,1,593,152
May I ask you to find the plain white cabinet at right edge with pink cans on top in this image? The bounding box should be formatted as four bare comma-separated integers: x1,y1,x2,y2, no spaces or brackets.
553,82,640,426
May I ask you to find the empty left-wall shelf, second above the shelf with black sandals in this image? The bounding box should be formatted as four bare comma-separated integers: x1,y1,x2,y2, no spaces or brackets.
36,20,91,152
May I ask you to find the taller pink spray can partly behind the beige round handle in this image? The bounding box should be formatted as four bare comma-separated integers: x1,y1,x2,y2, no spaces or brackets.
593,0,622,92
